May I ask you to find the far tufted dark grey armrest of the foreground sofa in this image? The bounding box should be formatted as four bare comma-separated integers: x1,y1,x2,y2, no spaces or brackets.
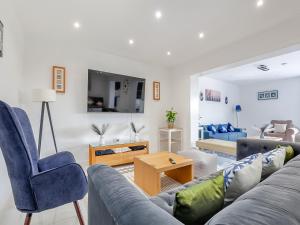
237,138,300,160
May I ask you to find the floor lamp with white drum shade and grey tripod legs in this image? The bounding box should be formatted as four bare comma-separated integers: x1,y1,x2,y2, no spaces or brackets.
32,89,57,155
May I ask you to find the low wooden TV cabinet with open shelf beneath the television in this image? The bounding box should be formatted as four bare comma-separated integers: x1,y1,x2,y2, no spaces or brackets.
89,141,149,166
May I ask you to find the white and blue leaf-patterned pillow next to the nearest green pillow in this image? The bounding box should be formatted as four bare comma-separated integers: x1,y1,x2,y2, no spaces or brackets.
223,153,262,205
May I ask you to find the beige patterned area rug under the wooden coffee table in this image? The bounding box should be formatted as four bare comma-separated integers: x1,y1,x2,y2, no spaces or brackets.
114,165,182,196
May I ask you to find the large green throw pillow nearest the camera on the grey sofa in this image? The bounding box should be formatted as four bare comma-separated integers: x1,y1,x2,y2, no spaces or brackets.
174,171,225,225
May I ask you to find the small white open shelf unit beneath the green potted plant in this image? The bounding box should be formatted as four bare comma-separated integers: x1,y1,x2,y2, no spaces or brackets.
158,128,183,153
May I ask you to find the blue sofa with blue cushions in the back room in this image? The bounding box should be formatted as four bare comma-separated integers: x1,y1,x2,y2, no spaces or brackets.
199,123,247,141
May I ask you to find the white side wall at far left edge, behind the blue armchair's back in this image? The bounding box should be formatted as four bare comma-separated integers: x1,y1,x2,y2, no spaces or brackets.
0,1,23,213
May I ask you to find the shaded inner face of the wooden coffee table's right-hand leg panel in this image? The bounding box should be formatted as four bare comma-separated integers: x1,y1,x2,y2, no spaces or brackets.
165,165,194,184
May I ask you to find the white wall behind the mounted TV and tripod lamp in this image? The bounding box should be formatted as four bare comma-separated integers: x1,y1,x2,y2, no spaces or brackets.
21,41,170,161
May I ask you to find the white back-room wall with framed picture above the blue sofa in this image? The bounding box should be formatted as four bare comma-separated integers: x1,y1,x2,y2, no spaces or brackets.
198,77,240,125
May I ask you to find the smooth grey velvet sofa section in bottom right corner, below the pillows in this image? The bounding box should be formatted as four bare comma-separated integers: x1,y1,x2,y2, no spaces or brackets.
206,156,300,225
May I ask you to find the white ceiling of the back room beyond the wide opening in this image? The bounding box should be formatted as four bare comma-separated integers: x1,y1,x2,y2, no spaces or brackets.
209,51,300,85
